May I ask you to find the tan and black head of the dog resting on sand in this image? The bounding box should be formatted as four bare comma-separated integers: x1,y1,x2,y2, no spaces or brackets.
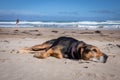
79,44,108,63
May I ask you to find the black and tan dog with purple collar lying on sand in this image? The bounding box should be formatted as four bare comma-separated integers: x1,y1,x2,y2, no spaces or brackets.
21,37,108,63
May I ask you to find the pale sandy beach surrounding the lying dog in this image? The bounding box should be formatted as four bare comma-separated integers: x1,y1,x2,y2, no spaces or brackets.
0,28,120,80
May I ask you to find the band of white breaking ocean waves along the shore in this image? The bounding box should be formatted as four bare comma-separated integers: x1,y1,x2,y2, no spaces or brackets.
0,21,120,30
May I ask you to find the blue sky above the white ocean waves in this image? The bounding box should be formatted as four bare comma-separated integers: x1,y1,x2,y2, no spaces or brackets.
0,0,120,21
